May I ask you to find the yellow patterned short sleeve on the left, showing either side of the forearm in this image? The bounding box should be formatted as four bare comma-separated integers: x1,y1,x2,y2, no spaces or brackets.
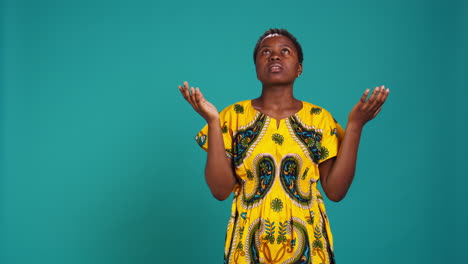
195,107,233,158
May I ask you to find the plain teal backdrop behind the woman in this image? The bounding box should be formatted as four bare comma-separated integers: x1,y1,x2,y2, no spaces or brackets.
0,0,468,264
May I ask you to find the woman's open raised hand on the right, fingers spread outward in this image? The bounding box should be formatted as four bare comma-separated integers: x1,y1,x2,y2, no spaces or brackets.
348,85,390,127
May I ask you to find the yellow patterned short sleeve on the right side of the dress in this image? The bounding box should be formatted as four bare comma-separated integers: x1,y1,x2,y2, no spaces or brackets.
319,111,345,163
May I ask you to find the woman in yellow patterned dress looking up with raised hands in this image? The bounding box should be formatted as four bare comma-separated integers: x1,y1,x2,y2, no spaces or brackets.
179,29,389,263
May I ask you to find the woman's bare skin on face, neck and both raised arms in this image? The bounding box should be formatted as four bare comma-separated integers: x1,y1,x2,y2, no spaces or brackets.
179,35,389,202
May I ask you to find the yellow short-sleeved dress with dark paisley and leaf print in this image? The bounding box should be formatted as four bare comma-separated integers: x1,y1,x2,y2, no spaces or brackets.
195,100,344,264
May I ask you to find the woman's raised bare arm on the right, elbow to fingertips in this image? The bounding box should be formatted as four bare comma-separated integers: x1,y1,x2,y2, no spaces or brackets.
319,86,390,202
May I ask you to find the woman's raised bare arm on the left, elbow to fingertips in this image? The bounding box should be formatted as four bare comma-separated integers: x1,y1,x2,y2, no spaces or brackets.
179,82,236,201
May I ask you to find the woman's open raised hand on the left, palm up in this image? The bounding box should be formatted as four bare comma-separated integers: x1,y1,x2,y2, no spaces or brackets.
179,82,219,123
